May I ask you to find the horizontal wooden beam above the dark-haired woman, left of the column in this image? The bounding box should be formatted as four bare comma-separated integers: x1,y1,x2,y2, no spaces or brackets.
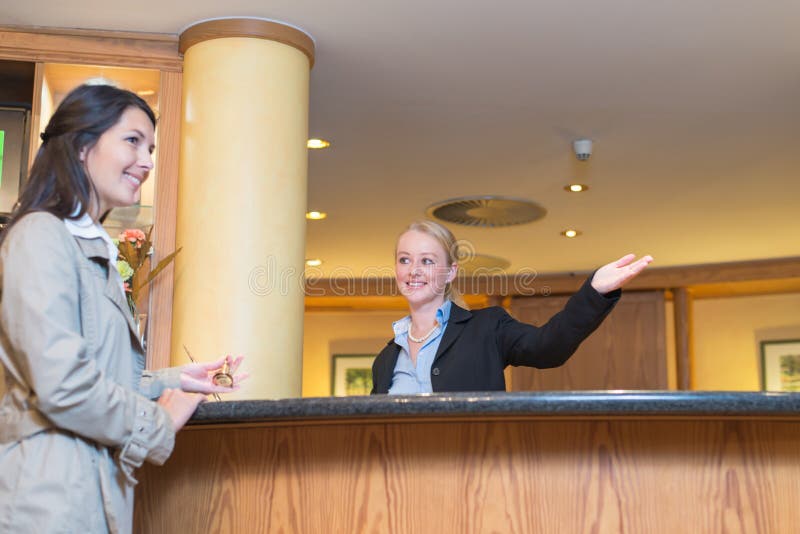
0,26,183,72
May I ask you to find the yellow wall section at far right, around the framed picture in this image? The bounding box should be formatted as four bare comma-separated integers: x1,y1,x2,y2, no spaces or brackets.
693,293,800,391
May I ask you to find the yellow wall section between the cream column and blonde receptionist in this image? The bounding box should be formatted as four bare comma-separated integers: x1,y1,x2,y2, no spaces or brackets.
303,310,406,397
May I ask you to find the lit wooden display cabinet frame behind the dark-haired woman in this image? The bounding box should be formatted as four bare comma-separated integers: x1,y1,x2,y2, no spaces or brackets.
0,26,183,368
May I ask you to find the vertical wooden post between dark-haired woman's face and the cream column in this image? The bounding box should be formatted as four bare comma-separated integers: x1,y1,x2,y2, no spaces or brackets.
147,72,183,369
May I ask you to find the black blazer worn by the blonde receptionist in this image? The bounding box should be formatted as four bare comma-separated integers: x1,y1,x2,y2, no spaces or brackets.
372,278,621,394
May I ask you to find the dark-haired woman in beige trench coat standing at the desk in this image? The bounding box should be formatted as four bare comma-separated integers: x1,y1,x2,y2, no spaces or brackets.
0,85,244,533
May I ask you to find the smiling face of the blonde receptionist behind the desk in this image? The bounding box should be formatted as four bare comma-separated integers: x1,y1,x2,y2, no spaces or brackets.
395,230,457,308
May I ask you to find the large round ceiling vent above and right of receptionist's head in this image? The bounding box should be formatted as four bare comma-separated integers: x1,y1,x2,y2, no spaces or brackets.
427,196,547,227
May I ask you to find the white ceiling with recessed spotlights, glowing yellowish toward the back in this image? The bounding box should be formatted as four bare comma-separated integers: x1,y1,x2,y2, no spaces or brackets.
0,0,800,275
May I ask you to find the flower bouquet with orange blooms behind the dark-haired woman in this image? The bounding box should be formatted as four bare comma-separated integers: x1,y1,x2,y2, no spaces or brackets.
115,226,183,318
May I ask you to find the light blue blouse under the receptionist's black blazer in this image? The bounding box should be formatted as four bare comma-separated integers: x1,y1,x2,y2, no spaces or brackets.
389,300,450,395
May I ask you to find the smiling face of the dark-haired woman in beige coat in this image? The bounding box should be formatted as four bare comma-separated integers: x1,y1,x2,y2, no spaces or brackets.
80,107,155,220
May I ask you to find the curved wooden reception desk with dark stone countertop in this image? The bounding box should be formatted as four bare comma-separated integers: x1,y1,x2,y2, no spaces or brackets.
135,391,800,534
